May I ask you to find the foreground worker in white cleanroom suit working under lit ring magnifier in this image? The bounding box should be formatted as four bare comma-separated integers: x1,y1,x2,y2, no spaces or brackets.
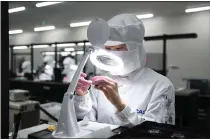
74,14,175,127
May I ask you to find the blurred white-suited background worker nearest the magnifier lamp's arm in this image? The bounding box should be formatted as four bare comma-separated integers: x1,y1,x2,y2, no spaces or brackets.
62,57,77,82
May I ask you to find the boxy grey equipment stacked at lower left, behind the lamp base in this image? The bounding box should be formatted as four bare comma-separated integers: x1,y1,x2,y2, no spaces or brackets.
9,89,40,138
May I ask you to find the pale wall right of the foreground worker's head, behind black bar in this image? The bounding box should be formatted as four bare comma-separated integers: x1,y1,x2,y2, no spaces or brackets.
144,11,210,86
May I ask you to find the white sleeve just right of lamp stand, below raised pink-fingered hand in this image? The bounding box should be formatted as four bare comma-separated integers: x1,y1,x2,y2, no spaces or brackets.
74,89,97,121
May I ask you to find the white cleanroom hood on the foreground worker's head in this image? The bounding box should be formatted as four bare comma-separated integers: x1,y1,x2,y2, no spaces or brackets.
105,14,146,76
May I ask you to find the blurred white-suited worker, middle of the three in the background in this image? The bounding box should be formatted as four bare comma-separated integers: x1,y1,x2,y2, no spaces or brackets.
39,56,55,81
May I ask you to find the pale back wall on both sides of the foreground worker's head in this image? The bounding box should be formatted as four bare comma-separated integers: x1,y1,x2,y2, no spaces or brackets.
10,11,210,87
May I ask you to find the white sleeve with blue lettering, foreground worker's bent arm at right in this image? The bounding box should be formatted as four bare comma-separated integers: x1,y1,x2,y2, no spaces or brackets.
116,86,175,127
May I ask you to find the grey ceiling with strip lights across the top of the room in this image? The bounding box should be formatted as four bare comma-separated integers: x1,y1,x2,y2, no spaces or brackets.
9,2,210,31
